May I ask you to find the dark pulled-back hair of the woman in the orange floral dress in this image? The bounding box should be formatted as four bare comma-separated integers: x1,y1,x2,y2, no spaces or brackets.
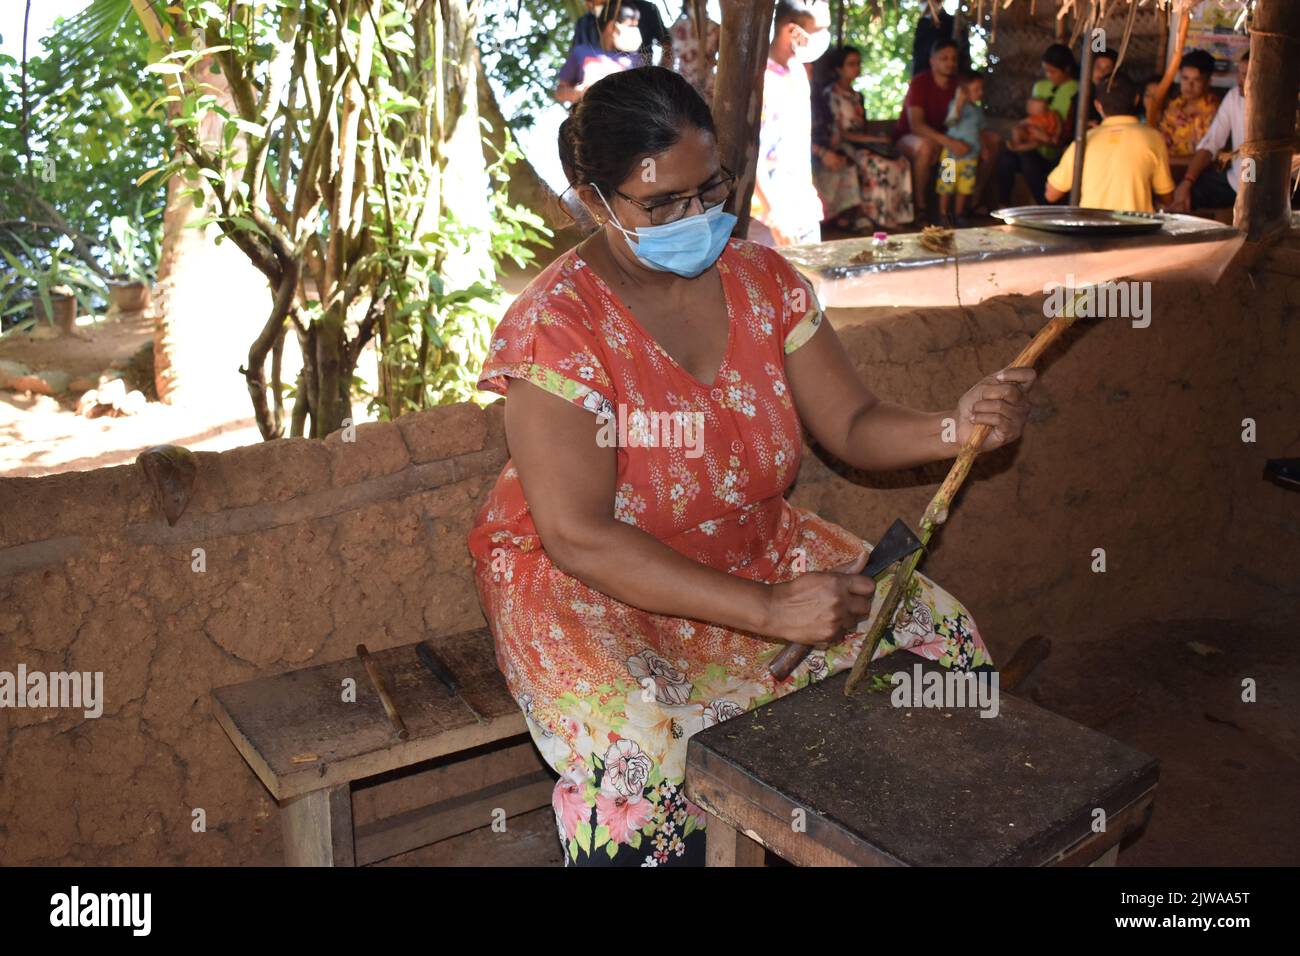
559,66,716,199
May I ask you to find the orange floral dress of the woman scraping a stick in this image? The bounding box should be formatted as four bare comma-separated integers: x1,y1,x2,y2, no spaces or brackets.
469,239,992,866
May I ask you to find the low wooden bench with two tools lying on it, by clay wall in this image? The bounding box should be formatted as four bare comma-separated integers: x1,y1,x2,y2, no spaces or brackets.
212,628,555,866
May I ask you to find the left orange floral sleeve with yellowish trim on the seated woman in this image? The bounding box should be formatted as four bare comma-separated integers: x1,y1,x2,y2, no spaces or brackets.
478,280,615,416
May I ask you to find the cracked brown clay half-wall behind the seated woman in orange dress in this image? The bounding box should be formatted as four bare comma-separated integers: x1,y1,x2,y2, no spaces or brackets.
0,256,1300,865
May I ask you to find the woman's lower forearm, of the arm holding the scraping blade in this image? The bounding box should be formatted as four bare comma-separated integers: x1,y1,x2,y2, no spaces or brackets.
547,519,771,633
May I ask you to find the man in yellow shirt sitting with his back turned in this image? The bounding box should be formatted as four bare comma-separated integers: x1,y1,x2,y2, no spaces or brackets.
1047,75,1174,212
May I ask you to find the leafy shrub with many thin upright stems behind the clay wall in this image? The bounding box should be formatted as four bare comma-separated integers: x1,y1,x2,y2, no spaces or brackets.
148,0,538,438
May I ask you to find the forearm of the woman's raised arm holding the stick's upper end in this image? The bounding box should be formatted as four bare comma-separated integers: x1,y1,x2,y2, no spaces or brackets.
840,402,959,471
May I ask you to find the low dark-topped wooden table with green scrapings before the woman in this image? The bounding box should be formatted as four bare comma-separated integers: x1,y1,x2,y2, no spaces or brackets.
685,652,1160,866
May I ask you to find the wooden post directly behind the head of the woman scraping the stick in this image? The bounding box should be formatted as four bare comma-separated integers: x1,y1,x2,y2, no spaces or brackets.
714,0,769,238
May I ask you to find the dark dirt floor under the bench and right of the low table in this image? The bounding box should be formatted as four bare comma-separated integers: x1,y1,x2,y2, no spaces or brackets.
378,620,1300,866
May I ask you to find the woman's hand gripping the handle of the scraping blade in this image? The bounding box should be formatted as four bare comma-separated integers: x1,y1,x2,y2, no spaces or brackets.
764,551,876,645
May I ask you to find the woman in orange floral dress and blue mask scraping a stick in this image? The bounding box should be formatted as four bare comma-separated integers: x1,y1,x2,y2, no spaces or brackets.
468,66,1034,866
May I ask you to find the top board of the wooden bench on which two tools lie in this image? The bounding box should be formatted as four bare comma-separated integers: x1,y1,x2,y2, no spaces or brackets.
212,628,528,800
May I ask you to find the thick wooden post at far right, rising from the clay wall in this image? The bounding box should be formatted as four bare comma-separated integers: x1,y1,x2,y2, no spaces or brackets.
1232,0,1300,242
